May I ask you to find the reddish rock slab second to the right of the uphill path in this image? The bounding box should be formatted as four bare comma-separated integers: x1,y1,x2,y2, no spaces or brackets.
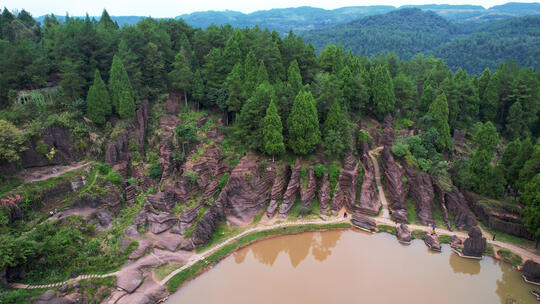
406,168,435,225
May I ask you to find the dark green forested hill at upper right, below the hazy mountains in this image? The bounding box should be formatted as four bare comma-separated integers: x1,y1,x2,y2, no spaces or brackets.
302,8,540,74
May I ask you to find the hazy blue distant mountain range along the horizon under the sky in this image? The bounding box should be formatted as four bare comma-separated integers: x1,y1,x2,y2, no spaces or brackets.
36,2,540,34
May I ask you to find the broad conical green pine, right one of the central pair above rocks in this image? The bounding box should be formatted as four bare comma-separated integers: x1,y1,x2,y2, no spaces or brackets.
287,92,321,155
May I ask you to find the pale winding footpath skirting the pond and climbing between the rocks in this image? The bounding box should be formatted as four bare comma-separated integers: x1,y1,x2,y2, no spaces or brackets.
10,147,540,289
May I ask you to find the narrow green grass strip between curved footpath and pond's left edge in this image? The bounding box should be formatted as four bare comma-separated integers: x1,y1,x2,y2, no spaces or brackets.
167,223,351,292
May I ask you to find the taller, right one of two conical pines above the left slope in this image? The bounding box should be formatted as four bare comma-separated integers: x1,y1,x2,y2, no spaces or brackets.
109,55,135,118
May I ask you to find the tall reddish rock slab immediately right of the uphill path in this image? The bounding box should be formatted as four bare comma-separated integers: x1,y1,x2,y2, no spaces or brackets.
381,145,409,223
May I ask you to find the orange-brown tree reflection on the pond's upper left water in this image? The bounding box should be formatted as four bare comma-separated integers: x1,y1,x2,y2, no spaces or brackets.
234,231,342,268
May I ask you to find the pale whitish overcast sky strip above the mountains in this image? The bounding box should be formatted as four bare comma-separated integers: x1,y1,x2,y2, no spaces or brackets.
4,0,538,18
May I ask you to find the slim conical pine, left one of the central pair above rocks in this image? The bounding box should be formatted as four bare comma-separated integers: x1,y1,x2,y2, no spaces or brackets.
263,100,285,160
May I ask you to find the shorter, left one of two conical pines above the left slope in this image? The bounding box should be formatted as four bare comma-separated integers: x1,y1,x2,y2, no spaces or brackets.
86,70,112,124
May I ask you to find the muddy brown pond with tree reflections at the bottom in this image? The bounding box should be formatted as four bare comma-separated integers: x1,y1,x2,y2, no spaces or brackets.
166,230,537,304
